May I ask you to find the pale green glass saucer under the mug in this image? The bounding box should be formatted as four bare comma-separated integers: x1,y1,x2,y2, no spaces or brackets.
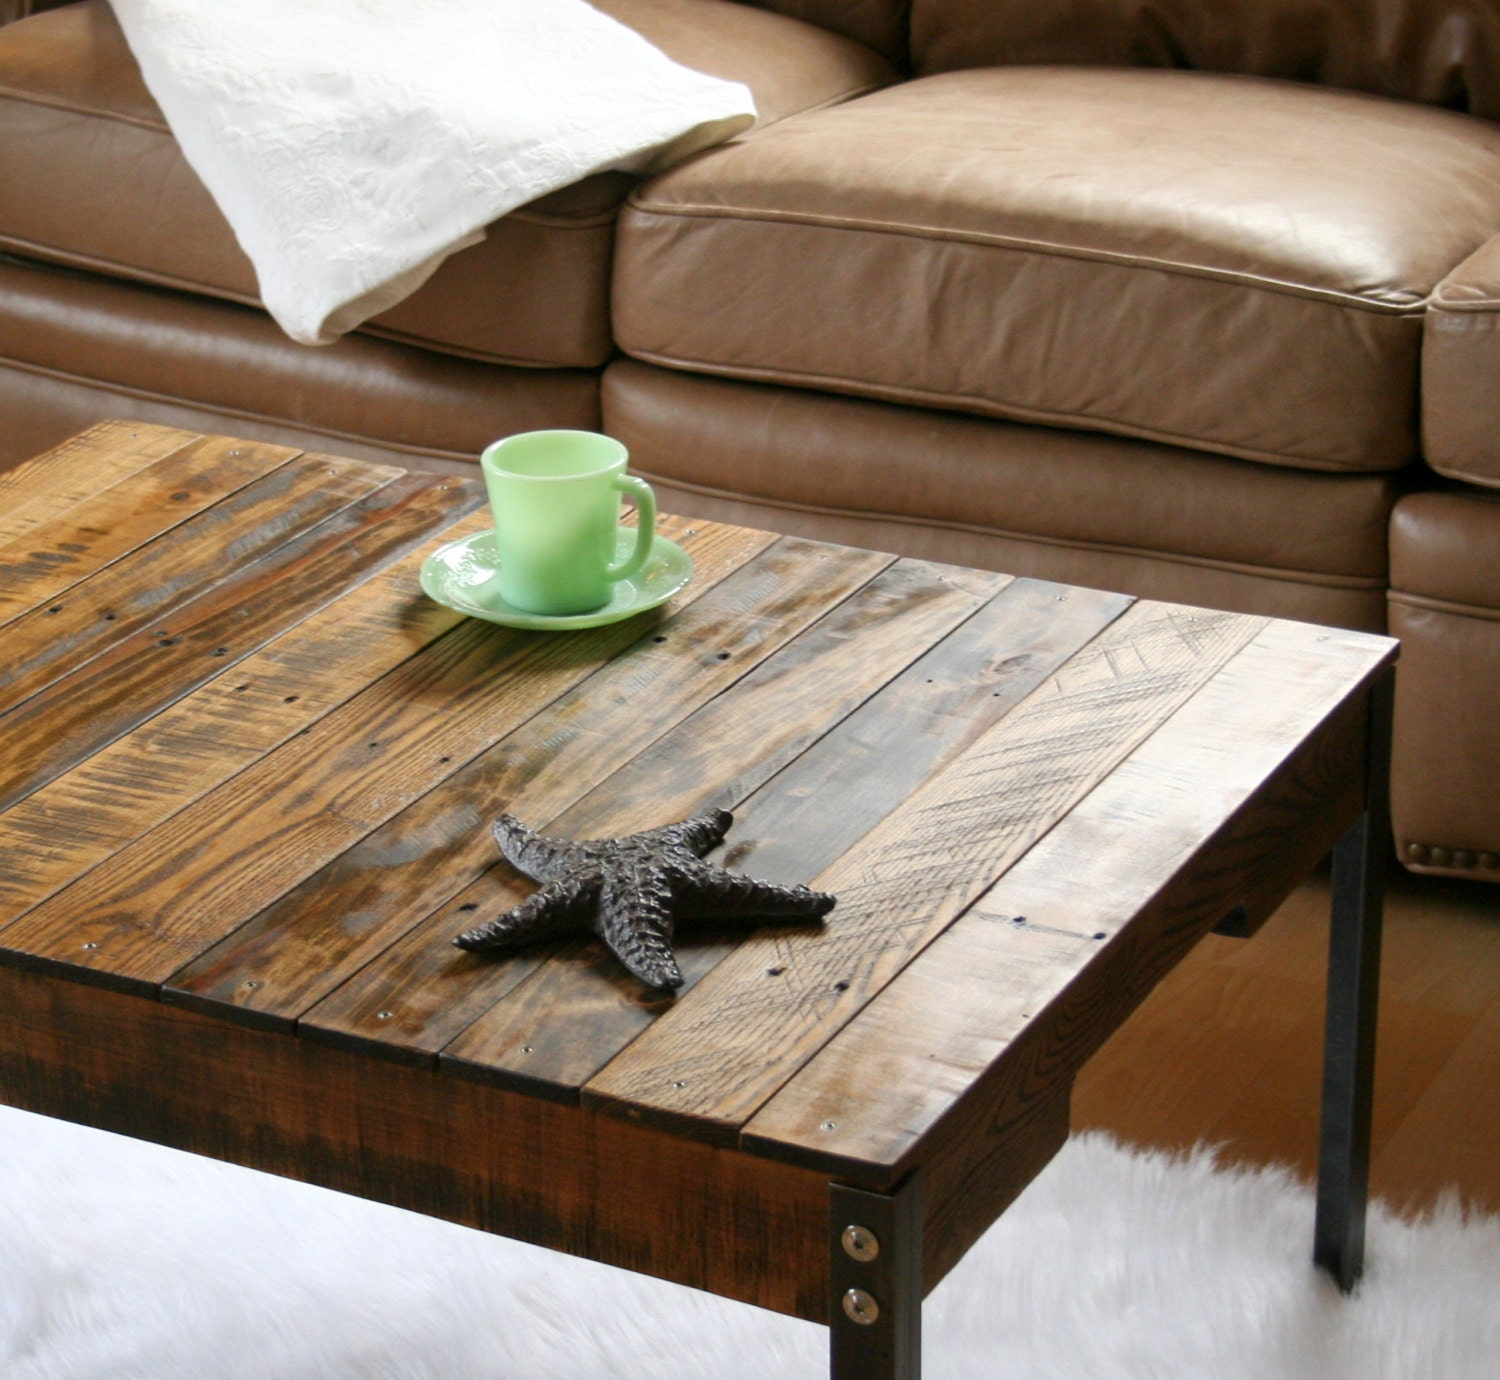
422,528,693,633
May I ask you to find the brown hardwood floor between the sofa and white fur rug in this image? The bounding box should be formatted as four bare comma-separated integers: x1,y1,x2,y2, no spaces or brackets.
1073,869,1500,1212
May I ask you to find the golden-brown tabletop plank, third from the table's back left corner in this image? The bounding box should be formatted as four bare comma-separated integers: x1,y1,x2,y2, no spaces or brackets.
0,440,402,713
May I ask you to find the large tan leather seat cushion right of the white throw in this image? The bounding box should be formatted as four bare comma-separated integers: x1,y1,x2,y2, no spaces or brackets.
615,68,1500,470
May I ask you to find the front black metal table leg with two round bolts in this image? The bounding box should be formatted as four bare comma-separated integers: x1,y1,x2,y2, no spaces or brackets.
828,1175,923,1380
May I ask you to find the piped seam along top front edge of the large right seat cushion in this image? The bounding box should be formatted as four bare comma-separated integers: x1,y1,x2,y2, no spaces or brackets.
629,195,1431,317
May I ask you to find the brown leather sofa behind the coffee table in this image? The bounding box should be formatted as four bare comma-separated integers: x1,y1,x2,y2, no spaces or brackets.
0,0,1500,881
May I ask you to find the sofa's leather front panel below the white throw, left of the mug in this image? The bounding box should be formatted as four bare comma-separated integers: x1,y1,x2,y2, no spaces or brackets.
0,255,599,462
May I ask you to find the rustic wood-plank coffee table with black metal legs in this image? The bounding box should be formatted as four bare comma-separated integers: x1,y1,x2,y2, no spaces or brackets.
0,423,1395,1380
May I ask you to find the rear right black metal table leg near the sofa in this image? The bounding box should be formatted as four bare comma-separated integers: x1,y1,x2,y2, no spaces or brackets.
1313,672,1394,1293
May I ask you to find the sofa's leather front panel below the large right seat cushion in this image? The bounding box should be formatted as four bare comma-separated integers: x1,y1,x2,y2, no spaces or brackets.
603,360,1398,630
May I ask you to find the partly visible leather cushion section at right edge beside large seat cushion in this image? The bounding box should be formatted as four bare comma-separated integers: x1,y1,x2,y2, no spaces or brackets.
1422,236,1500,489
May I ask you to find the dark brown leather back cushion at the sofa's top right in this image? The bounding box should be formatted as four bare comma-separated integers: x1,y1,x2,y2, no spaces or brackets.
911,0,1500,120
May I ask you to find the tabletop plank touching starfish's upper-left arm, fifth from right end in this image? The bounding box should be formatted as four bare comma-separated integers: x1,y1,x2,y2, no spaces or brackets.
164,524,822,1025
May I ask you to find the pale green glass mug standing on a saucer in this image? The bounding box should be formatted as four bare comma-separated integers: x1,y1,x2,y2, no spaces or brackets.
480,431,656,617
